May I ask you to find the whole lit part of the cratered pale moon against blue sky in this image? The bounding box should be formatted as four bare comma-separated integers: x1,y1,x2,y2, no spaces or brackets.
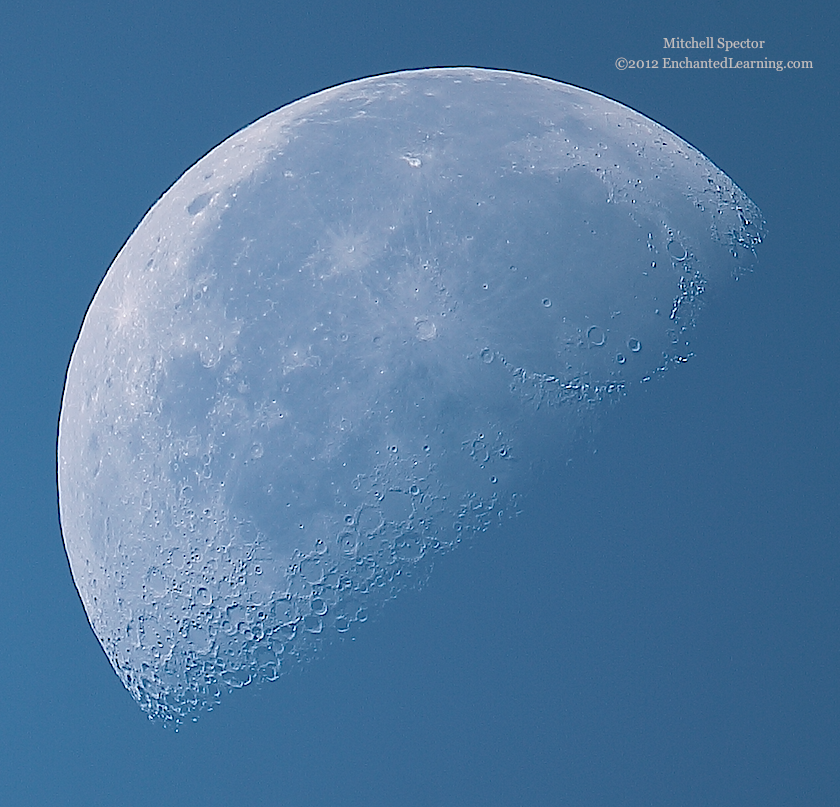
58,68,763,721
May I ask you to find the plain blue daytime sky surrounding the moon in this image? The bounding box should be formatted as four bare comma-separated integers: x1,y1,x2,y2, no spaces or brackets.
0,0,840,807
